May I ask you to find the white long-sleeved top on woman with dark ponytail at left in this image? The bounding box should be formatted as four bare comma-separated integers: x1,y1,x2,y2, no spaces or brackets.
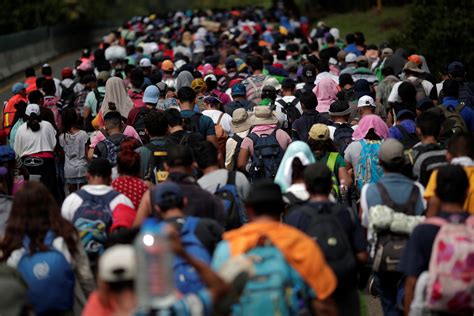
13,121,56,157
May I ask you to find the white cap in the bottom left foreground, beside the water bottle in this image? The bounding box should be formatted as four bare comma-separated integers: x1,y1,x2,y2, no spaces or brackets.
99,245,137,282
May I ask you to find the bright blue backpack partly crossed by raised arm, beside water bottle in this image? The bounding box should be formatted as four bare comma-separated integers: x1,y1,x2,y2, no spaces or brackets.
173,216,211,294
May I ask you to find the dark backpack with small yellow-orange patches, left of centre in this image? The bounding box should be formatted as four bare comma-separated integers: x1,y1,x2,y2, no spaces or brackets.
144,137,169,184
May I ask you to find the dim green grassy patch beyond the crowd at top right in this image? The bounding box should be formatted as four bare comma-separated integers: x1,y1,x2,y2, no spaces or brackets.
321,6,409,45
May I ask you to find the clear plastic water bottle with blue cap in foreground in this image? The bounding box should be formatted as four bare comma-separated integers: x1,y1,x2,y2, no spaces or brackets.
135,219,176,315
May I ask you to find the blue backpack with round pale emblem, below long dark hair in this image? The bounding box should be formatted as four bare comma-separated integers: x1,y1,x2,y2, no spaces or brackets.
17,231,74,315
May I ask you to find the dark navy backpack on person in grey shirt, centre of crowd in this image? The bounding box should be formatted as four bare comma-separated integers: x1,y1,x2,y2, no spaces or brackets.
214,171,247,230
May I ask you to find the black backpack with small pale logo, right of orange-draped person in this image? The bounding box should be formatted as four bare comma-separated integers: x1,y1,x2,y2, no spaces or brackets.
303,203,356,288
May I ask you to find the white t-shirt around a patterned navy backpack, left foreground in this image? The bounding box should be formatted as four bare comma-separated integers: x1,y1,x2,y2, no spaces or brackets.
61,184,135,221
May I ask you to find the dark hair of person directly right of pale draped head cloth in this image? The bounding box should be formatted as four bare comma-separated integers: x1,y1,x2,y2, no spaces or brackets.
304,162,332,195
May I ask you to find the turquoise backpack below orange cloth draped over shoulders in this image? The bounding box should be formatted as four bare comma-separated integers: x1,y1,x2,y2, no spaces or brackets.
232,245,300,316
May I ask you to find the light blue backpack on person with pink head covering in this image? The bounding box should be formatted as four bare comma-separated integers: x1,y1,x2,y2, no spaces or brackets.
356,139,383,192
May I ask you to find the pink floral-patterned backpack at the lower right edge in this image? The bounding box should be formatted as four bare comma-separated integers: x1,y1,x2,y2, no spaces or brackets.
425,215,474,312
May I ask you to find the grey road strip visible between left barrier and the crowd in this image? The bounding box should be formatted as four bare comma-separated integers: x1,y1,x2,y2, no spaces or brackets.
0,50,82,104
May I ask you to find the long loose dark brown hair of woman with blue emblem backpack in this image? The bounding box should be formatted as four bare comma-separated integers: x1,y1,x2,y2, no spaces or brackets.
0,182,79,260
